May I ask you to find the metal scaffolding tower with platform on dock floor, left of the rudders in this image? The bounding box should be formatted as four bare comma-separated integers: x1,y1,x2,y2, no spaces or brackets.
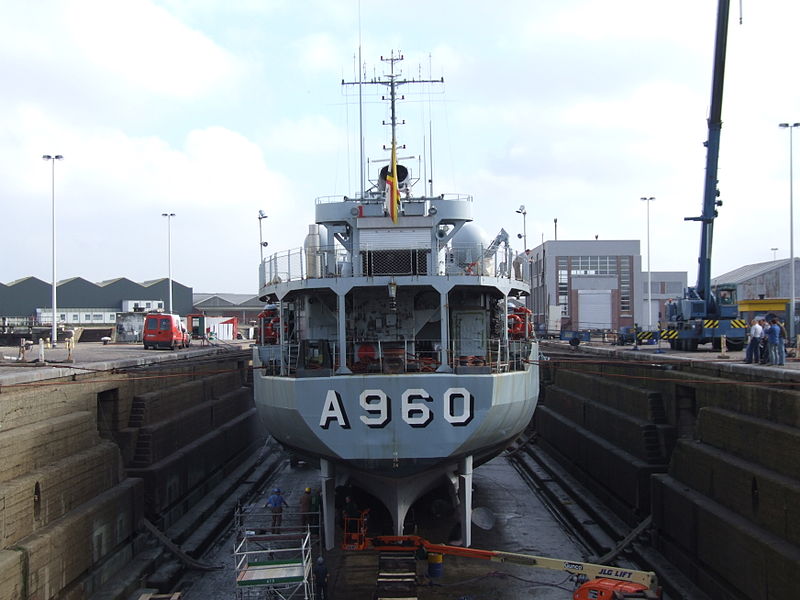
234,507,319,600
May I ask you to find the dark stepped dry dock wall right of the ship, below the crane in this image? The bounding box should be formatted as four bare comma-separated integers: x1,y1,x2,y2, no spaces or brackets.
535,346,800,600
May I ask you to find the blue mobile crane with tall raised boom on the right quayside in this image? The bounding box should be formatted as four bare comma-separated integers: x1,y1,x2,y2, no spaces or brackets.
660,0,747,351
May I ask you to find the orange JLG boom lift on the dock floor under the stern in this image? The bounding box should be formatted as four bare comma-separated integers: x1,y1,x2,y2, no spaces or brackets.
354,536,661,600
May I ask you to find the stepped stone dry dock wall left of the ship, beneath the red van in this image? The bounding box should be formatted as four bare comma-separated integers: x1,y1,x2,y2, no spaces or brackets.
0,355,263,600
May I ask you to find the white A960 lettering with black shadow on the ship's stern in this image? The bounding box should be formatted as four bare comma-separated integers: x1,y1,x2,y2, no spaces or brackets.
319,387,475,429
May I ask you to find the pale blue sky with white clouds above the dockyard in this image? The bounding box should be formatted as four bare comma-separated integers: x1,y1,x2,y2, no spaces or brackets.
0,0,800,295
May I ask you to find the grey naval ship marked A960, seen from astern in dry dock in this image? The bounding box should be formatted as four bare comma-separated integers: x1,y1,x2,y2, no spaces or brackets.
253,59,539,545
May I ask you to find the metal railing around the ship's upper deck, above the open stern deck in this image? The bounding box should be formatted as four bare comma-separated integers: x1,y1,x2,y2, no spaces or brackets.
260,244,520,287
